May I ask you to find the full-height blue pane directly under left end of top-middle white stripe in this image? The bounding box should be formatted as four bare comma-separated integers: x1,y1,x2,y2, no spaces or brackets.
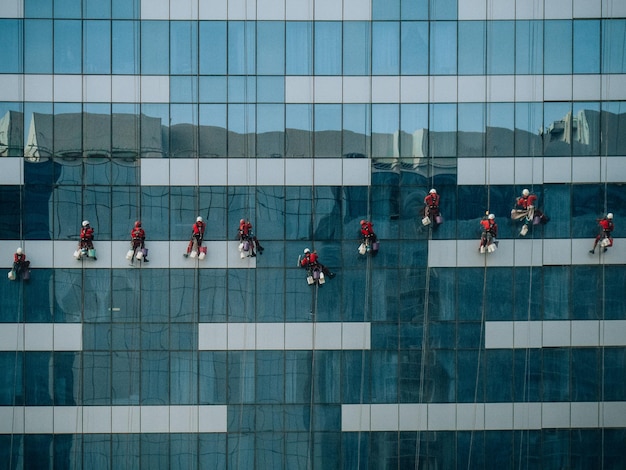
141,21,170,75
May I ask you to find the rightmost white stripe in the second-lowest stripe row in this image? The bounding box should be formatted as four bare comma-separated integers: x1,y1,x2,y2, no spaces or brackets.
485,320,626,349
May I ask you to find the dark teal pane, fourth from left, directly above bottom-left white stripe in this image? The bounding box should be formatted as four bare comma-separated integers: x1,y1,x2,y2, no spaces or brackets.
81,351,112,405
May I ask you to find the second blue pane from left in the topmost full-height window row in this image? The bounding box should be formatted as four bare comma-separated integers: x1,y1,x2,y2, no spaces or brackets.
24,20,54,73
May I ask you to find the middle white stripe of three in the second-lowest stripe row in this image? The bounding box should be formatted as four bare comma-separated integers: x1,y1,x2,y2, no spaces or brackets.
198,322,371,351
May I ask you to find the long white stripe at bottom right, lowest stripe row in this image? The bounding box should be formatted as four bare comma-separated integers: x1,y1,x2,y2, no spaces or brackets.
341,401,626,432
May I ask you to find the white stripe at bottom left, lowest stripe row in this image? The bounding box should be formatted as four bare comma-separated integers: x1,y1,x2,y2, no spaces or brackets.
0,405,228,434
